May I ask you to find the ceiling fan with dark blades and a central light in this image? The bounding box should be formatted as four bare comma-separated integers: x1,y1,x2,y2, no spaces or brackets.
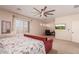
33,6,55,17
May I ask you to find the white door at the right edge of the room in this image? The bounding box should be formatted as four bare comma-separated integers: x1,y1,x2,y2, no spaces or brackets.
72,20,79,43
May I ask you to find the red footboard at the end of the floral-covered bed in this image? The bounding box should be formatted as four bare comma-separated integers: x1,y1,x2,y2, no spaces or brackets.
24,34,53,53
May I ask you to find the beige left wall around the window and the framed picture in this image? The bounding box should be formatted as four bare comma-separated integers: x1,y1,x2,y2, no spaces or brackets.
0,10,43,36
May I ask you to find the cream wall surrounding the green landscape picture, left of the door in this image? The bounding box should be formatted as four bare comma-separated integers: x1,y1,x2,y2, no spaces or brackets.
55,14,79,41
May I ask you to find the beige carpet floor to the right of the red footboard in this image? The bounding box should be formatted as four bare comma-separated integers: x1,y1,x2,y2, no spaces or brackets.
49,39,79,54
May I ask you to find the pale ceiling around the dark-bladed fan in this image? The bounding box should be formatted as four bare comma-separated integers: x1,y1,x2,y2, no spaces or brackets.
0,5,79,20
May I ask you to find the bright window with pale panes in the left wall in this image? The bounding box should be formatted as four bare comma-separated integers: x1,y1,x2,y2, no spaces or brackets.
16,20,29,33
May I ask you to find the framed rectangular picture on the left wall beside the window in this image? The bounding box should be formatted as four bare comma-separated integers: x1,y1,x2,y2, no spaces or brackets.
1,21,11,34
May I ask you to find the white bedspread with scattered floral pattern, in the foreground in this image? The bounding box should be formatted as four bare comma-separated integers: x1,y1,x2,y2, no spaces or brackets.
0,36,45,54
